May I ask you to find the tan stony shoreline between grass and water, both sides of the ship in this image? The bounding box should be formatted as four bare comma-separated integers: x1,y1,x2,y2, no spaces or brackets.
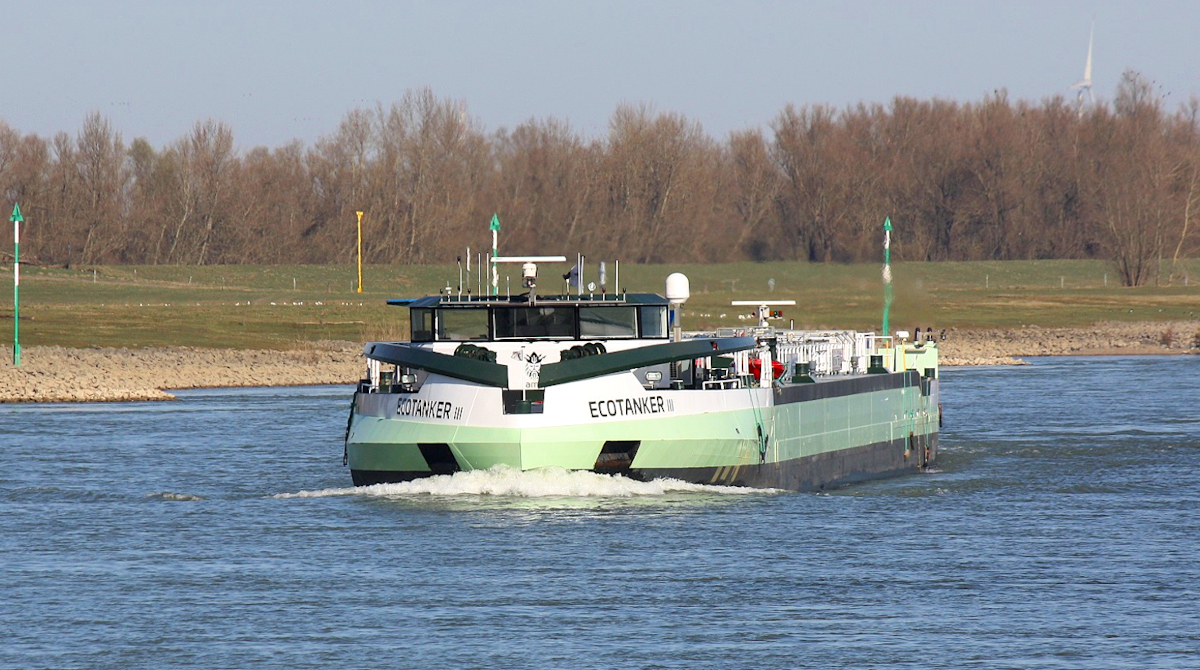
0,321,1200,402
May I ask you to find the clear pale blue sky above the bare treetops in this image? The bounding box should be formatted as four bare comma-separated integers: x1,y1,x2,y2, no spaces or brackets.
0,0,1200,149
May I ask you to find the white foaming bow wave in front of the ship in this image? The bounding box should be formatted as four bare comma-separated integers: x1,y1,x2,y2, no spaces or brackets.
275,466,778,498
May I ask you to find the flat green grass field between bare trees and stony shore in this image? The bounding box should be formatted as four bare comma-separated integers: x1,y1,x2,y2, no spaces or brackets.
0,261,1200,348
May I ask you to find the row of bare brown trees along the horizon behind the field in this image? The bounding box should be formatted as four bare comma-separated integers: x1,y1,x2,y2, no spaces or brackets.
0,72,1200,285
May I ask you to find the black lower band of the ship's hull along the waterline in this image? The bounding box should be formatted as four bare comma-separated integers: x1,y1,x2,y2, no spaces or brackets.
350,433,937,491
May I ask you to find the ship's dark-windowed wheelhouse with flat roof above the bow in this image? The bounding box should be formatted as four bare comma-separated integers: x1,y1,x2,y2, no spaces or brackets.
388,293,670,342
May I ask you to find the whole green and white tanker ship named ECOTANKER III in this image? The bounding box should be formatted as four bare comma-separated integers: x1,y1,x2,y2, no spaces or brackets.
344,257,941,491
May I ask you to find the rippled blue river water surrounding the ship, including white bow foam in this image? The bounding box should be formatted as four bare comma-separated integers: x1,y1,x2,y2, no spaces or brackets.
0,357,1200,669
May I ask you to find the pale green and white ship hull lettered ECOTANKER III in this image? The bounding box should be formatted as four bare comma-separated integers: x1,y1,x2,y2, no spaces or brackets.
347,371,938,491
